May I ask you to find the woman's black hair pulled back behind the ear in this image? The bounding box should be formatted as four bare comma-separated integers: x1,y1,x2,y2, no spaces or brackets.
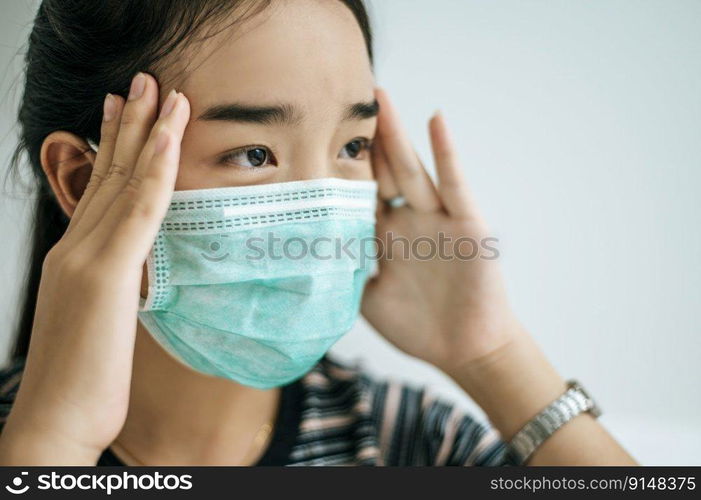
5,0,373,358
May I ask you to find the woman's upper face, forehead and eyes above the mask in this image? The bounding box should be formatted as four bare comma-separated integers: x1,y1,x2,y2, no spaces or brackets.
170,0,377,190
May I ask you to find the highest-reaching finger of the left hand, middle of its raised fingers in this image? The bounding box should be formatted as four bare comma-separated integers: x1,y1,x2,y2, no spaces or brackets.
77,73,158,234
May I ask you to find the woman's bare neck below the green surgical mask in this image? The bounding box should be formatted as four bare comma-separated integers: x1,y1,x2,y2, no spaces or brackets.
113,323,280,465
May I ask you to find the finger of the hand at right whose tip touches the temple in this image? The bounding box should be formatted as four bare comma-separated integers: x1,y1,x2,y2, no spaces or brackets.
376,88,441,212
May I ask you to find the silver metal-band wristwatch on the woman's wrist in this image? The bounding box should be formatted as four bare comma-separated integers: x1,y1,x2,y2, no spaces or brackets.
509,379,601,464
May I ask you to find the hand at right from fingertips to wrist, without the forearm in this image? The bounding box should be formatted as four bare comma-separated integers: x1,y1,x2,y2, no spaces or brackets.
362,88,520,374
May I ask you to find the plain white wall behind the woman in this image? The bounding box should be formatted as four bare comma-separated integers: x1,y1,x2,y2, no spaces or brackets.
0,0,701,465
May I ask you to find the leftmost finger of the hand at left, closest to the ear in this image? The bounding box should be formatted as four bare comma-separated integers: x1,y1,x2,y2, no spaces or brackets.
66,94,124,234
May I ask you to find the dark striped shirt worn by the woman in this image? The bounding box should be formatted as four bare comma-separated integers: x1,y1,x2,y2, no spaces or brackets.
0,356,519,466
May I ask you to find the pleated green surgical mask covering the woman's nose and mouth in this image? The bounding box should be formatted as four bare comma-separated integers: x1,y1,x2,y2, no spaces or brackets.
139,179,377,389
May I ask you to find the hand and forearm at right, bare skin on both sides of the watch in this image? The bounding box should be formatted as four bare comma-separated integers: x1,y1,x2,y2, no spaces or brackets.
362,89,637,465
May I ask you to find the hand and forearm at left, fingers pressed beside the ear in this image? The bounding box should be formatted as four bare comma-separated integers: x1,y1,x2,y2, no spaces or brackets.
0,73,190,465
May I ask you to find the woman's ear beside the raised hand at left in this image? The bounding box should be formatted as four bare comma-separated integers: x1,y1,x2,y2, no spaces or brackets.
40,131,97,217
